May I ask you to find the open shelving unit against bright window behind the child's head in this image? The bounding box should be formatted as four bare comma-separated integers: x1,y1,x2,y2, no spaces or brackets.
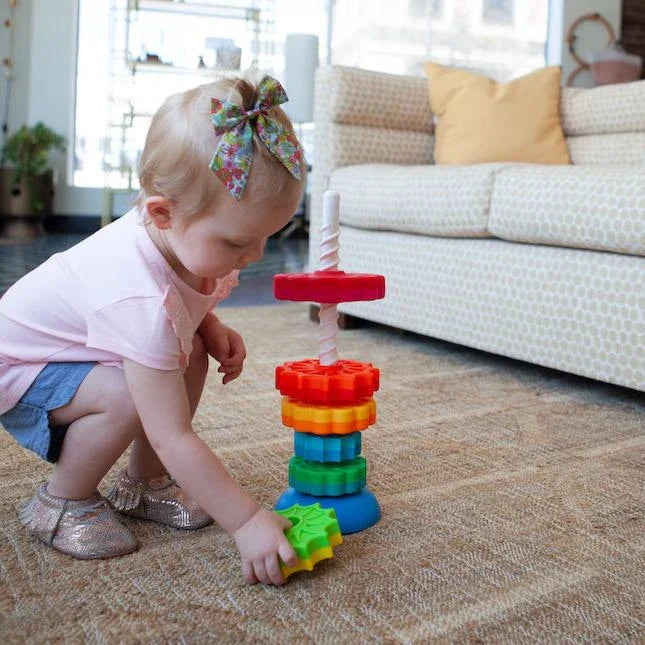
102,0,275,224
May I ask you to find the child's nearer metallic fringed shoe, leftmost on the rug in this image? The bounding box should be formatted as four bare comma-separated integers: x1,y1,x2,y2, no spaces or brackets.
19,483,139,560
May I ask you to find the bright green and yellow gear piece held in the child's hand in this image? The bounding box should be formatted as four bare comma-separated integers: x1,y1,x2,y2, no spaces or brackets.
276,504,343,578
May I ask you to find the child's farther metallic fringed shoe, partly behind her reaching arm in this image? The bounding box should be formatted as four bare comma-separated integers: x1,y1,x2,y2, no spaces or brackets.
106,470,213,529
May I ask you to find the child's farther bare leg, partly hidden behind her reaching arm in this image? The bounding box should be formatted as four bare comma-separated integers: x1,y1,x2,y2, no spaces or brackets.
128,334,208,479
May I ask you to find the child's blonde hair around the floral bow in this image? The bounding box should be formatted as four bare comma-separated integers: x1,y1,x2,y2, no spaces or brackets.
136,78,306,217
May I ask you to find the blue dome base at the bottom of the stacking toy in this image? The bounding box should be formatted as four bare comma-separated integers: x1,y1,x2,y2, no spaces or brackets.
275,487,381,535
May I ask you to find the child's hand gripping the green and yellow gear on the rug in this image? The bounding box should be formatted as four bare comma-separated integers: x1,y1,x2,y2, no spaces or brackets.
233,508,298,585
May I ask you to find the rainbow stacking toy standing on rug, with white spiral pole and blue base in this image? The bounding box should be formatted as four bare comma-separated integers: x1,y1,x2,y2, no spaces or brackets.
273,191,385,532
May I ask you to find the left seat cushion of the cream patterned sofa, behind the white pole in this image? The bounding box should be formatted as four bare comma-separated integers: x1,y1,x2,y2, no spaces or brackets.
329,164,504,237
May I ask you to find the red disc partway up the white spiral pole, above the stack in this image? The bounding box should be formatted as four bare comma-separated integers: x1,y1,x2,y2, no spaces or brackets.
273,271,385,303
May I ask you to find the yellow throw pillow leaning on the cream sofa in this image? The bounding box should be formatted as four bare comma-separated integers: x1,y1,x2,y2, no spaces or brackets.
425,63,570,164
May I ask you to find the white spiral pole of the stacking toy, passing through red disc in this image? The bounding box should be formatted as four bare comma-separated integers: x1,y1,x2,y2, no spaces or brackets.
318,190,340,365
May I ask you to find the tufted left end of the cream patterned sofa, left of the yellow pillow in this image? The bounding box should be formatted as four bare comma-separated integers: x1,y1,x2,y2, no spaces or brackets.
309,66,434,270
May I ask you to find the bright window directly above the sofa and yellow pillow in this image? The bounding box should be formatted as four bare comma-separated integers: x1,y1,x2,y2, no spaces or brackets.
331,0,549,82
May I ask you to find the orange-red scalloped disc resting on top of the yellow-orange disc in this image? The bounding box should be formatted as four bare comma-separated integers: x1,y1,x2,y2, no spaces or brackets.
275,358,379,405
